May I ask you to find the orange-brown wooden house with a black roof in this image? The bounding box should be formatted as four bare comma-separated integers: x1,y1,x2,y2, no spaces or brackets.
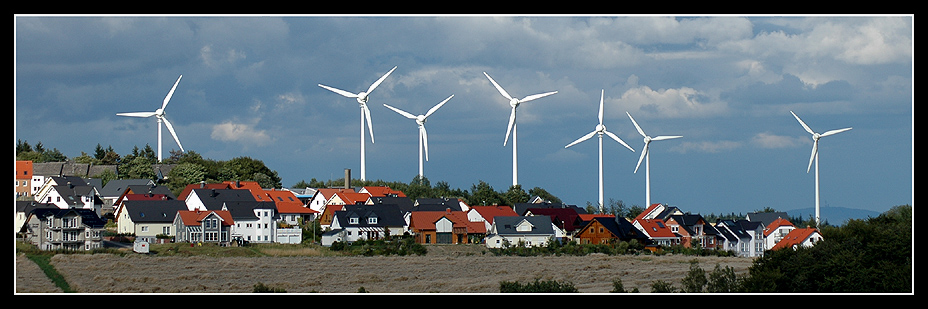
573,217,649,245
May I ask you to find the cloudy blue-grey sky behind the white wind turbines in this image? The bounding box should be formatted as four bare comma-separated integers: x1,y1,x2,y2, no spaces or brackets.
14,15,914,219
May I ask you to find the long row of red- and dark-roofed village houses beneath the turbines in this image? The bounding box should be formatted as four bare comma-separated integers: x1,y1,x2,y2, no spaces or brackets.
14,164,821,253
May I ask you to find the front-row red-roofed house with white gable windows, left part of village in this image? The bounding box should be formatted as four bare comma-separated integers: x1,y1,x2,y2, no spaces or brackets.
173,209,235,245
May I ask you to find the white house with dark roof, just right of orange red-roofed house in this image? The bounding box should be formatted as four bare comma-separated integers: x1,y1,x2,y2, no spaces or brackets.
485,216,555,249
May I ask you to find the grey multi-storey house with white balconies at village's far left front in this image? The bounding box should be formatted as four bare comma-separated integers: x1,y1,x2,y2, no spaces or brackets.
23,207,106,251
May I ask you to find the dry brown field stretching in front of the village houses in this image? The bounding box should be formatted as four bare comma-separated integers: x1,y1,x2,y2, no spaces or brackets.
15,245,753,293
